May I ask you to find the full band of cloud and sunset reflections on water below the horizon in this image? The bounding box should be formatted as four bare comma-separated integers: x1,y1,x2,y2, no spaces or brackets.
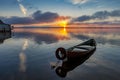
15,28,120,45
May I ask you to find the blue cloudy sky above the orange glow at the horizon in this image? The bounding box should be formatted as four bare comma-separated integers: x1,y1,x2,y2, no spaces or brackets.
0,0,120,24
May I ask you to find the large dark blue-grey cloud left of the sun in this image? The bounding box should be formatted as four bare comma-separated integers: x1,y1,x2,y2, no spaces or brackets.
0,10,59,24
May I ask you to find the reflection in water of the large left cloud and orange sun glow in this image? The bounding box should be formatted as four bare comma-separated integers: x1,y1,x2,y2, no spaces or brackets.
15,29,70,44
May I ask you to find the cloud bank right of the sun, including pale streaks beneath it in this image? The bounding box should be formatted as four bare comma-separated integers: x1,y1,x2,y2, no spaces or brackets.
72,10,120,23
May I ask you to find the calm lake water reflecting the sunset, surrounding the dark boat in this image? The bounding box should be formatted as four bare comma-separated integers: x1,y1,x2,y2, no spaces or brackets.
0,28,120,80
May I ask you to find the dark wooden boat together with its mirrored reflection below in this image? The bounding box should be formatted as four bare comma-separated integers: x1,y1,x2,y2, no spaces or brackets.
52,39,96,78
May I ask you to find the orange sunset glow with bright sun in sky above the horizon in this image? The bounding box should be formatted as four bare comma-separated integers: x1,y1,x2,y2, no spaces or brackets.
13,16,71,28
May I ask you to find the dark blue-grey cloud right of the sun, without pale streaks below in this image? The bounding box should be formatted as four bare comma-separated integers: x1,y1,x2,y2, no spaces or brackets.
73,10,120,22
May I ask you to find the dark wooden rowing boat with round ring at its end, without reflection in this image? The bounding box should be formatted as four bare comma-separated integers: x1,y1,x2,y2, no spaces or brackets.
55,39,96,60
